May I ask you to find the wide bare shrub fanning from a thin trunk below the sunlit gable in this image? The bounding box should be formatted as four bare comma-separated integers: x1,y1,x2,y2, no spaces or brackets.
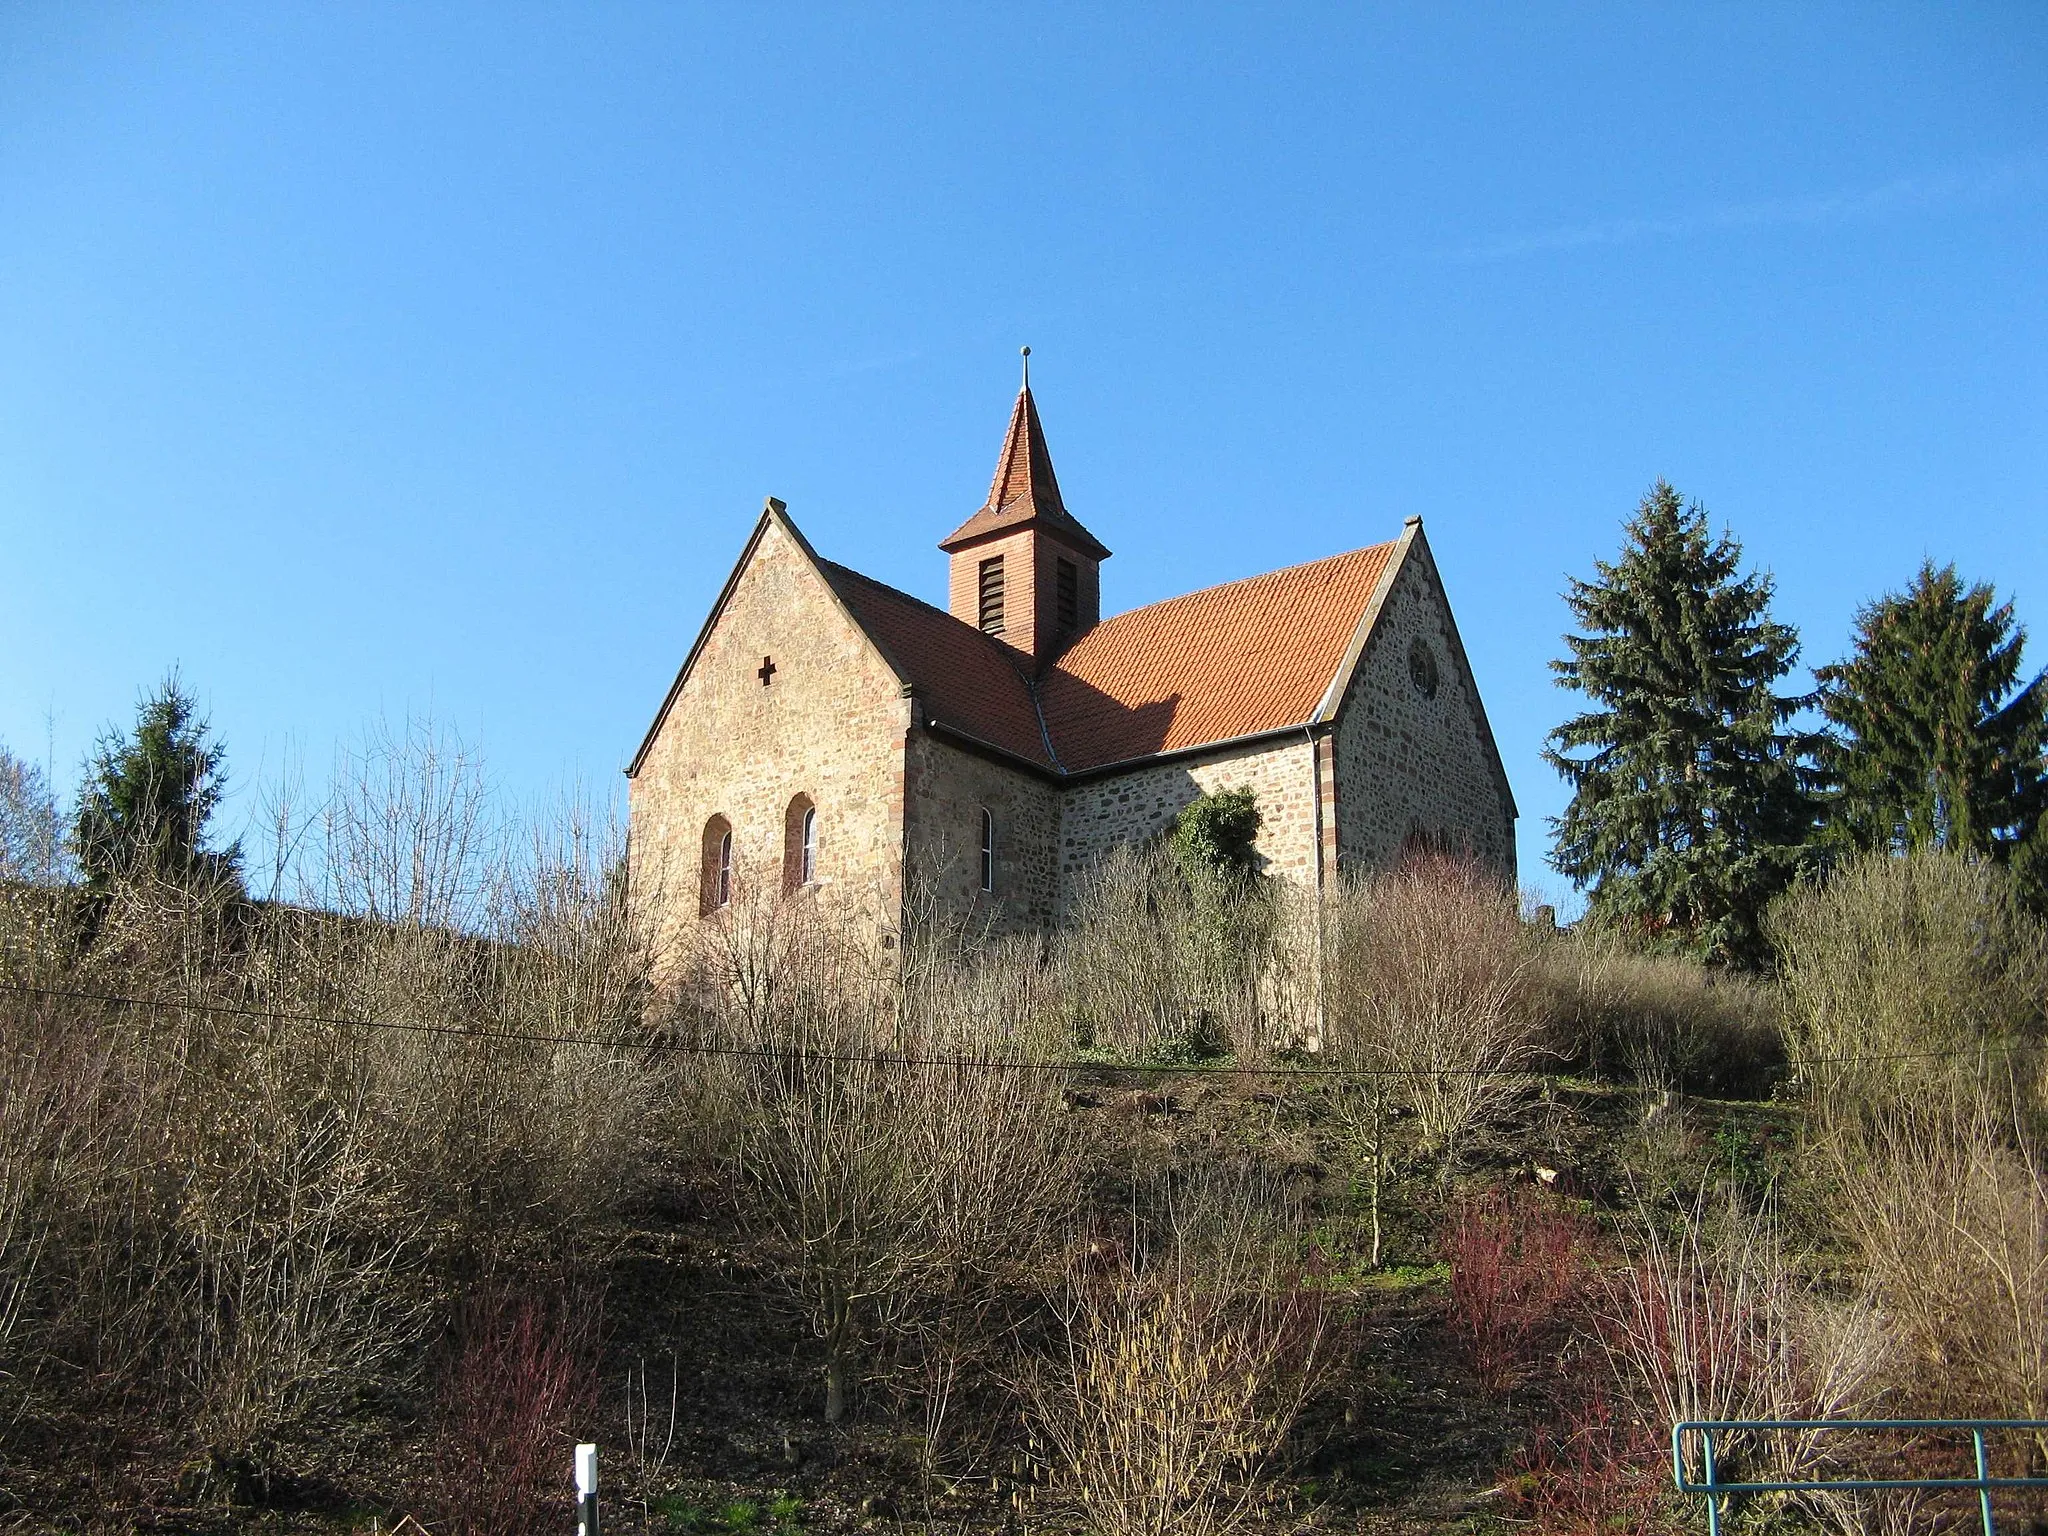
707,897,1079,1421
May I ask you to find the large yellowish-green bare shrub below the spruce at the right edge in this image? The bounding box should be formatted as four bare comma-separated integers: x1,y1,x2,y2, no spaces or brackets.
1767,848,2048,1104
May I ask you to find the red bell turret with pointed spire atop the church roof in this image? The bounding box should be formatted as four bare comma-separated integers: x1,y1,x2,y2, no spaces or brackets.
940,346,1110,662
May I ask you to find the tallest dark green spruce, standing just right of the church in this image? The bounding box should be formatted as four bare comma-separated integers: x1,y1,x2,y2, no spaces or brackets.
1544,479,1815,965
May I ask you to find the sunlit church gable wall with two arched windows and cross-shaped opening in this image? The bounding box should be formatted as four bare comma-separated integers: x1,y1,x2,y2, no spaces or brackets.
629,522,909,966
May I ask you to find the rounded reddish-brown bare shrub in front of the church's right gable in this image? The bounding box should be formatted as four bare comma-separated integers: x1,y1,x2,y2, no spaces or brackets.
1323,858,1542,1174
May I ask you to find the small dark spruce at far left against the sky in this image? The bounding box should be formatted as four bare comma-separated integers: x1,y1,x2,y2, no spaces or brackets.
72,674,242,895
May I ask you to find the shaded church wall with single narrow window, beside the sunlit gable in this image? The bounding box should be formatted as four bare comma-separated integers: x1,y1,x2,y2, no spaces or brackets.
903,731,1059,932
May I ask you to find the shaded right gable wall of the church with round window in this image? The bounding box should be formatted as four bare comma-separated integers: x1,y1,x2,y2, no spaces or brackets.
1335,541,1516,879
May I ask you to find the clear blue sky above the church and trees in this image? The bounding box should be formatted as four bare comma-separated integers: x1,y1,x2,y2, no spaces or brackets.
0,0,2048,901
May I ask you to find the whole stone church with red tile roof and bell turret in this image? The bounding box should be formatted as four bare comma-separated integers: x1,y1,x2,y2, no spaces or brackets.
627,381,1516,946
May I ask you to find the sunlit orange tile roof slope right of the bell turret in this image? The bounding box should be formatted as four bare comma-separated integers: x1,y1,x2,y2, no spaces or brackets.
1040,543,1395,772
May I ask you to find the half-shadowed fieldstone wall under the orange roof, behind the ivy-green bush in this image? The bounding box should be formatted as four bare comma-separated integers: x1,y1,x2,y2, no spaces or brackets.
1059,735,1317,921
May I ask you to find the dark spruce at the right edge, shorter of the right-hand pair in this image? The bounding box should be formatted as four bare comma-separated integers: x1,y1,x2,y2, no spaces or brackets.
1817,561,2048,866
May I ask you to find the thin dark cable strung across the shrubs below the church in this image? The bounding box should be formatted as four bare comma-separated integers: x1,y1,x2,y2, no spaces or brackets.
0,981,2034,1079
